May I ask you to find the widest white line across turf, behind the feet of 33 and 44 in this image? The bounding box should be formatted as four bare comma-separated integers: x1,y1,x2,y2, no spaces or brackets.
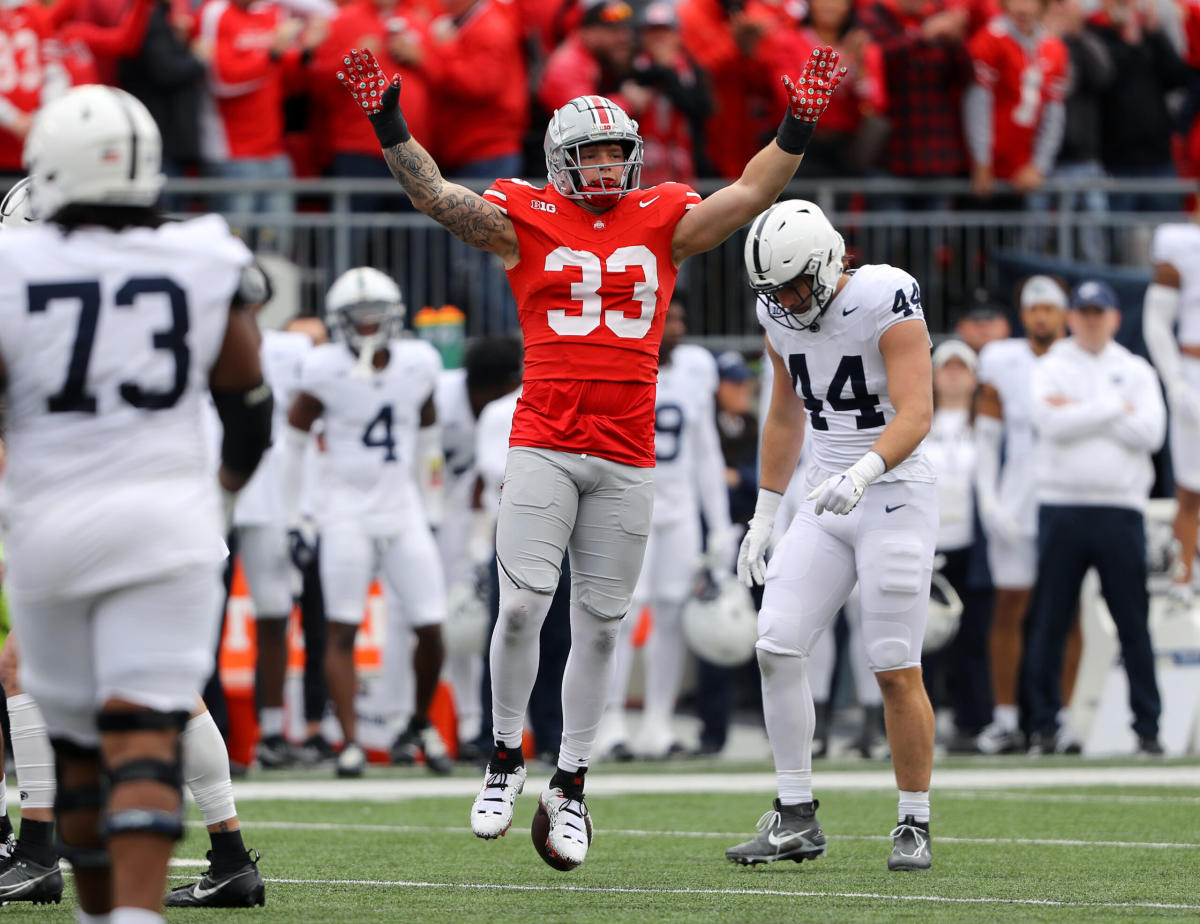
234,766,1200,803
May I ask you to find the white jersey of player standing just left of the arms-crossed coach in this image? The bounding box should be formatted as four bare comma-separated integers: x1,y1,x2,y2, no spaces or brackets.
978,337,1038,535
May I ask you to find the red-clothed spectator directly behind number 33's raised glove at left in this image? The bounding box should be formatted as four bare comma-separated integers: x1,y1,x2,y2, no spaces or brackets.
311,0,434,162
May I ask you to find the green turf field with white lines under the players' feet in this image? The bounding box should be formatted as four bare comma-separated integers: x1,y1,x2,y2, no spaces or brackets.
9,758,1200,922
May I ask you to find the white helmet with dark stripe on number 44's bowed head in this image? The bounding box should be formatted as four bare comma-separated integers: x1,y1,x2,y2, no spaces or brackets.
745,199,846,330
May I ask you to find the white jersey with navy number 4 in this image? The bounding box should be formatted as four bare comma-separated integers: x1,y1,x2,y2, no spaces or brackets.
300,340,442,536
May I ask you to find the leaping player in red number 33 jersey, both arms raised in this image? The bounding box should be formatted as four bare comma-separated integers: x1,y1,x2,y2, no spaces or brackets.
337,41,845,869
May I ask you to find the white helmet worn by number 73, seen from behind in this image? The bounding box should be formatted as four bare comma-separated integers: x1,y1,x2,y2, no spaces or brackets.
23,84,167,218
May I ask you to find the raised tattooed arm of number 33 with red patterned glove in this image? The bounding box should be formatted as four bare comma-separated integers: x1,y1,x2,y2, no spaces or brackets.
337,48,518,268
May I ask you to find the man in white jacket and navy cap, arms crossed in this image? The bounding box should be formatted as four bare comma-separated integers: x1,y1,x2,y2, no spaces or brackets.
1025,281,1166,754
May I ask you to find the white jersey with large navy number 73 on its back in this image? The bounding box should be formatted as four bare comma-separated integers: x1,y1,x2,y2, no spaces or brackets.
0,215,251,598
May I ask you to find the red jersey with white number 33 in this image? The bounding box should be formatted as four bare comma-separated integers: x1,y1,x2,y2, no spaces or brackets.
484,180,700,468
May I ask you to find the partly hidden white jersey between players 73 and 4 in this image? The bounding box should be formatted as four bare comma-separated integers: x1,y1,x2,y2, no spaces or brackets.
233,330,312,526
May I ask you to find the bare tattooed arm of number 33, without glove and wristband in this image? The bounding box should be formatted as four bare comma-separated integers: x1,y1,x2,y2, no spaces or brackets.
383,138,518,269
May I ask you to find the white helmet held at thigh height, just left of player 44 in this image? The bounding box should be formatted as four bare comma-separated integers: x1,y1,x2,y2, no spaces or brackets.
683,571,758,667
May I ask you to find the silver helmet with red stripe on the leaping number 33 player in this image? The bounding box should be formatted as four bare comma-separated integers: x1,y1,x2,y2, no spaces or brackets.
545,96,642,203
